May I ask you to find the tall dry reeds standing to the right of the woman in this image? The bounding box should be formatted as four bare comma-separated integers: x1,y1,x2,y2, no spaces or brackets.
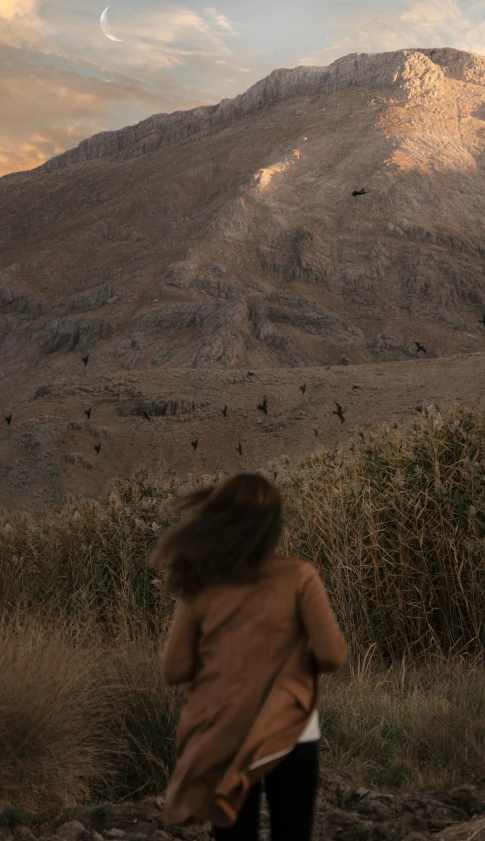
283,407,485,663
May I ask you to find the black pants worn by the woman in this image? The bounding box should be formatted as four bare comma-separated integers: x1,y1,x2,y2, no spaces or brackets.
213,741,319,841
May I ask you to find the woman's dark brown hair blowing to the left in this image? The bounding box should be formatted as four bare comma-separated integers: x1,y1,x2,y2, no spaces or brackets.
149,473,283,598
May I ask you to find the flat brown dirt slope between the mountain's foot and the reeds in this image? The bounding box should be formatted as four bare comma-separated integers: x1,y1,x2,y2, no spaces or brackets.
0,354,485,511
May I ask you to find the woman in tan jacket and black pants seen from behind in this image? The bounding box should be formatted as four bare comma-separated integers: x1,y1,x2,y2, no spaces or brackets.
149,473,348,841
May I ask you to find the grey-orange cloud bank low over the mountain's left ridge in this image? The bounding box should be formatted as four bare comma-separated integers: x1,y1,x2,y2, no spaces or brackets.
0,41,208,176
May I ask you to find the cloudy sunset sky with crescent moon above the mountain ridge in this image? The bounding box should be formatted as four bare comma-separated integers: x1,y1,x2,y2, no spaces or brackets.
0,0,485,176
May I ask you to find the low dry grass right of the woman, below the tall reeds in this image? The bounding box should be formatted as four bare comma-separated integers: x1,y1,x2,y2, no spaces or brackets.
320,657,485,793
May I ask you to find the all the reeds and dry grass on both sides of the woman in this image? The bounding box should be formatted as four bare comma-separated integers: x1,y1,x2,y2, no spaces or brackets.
0,407,485,810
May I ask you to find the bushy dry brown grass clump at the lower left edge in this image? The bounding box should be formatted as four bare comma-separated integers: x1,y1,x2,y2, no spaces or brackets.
0,621,115,810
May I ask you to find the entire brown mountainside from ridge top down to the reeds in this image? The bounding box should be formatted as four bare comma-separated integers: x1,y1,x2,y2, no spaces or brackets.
0,48,485,510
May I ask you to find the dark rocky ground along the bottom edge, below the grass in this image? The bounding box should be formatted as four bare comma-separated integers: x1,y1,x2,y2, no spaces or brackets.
0,774,485,841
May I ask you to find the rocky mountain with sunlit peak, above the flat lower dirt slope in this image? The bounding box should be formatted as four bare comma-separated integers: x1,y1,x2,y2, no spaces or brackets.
0,48,485,502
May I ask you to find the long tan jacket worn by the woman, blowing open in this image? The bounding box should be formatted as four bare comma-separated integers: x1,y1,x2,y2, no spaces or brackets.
162,555,348,827
